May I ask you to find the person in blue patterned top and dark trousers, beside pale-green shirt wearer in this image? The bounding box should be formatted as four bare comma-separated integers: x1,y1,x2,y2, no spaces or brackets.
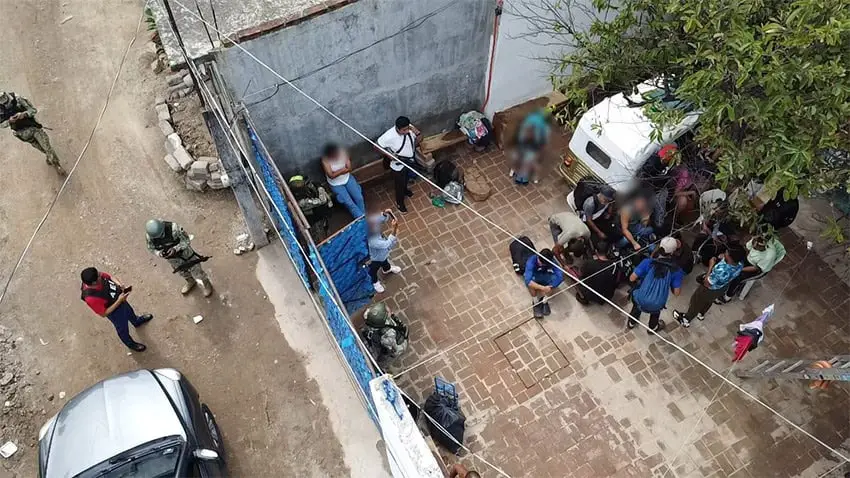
673,245,746,327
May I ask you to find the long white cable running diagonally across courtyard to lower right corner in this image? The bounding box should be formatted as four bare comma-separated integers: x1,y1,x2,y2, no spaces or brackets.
162,0,850,461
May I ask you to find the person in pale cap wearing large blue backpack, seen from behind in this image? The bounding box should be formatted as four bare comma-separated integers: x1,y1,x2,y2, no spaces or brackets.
627,237,685,333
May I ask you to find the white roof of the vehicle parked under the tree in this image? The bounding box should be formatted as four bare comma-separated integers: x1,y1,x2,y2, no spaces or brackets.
578,81,699,171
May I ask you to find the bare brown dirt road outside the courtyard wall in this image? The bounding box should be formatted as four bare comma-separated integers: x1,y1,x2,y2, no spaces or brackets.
0,0,360,477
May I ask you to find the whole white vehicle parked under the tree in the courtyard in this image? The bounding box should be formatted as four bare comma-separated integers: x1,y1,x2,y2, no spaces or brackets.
559,81,699,202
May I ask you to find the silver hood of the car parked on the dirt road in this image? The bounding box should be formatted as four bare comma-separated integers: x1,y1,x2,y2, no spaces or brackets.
45,370,186,478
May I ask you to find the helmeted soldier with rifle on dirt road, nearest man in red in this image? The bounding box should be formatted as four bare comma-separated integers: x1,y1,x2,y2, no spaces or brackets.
145,219,212,297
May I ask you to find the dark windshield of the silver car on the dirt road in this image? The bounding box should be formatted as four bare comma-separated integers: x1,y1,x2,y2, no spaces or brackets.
76,437,183,478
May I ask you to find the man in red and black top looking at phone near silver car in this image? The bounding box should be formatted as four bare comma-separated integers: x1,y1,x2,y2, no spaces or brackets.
80,267,153,352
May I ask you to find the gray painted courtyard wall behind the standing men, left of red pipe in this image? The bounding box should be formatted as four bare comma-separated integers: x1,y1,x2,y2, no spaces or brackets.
217,0,494,174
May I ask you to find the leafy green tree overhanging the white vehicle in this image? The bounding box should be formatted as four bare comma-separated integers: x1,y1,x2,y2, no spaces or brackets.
513,0,850,196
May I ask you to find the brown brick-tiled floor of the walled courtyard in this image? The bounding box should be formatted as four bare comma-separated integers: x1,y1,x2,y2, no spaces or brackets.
360,136,850,478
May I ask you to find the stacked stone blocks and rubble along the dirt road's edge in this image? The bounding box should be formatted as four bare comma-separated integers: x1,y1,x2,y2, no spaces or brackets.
155,97,230,191
